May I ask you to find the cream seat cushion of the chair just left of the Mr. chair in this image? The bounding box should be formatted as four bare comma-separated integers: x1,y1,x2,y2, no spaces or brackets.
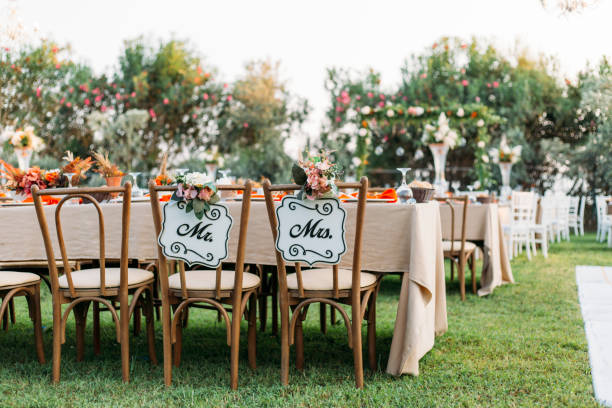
59,268,153,289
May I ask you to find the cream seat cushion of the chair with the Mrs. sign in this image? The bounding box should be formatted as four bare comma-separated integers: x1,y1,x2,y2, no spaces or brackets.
287,268,376,290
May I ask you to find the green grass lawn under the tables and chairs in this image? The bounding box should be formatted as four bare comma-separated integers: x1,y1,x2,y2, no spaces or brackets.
0,235,612,407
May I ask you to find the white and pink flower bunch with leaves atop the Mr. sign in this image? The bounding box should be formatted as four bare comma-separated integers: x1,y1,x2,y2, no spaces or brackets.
170,172,219,220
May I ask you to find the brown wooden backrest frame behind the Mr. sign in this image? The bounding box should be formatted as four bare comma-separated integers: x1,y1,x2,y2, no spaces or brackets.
149,180,252,299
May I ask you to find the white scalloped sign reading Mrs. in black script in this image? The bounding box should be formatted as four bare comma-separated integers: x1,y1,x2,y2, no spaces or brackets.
276,196,346,265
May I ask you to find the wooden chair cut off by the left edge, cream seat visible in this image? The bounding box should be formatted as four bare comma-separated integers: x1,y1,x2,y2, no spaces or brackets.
0,271,45,364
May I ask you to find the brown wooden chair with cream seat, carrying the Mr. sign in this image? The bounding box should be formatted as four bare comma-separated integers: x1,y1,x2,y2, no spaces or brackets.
149,181,261,390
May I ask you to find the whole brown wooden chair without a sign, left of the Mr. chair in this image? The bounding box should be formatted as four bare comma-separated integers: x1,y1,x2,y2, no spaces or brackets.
32,182,157,383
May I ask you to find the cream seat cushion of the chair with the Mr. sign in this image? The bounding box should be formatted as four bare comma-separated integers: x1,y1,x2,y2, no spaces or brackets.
168,270,259,290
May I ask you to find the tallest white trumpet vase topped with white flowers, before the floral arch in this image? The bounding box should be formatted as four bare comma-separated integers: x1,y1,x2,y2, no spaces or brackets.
423,112,460,194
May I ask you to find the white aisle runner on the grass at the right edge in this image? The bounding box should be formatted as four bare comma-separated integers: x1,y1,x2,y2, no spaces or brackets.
576,266,612,407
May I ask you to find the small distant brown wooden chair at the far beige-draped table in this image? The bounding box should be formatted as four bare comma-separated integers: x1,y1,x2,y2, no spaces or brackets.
436,196,477,300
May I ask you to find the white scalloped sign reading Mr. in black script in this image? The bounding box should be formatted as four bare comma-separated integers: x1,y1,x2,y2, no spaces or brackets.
158,201,233,268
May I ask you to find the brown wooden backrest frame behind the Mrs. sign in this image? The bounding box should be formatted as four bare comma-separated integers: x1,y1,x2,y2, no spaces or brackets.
263,177,368,299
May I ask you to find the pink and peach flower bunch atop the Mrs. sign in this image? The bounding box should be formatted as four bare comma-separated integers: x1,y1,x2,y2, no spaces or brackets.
291,152,341,200
